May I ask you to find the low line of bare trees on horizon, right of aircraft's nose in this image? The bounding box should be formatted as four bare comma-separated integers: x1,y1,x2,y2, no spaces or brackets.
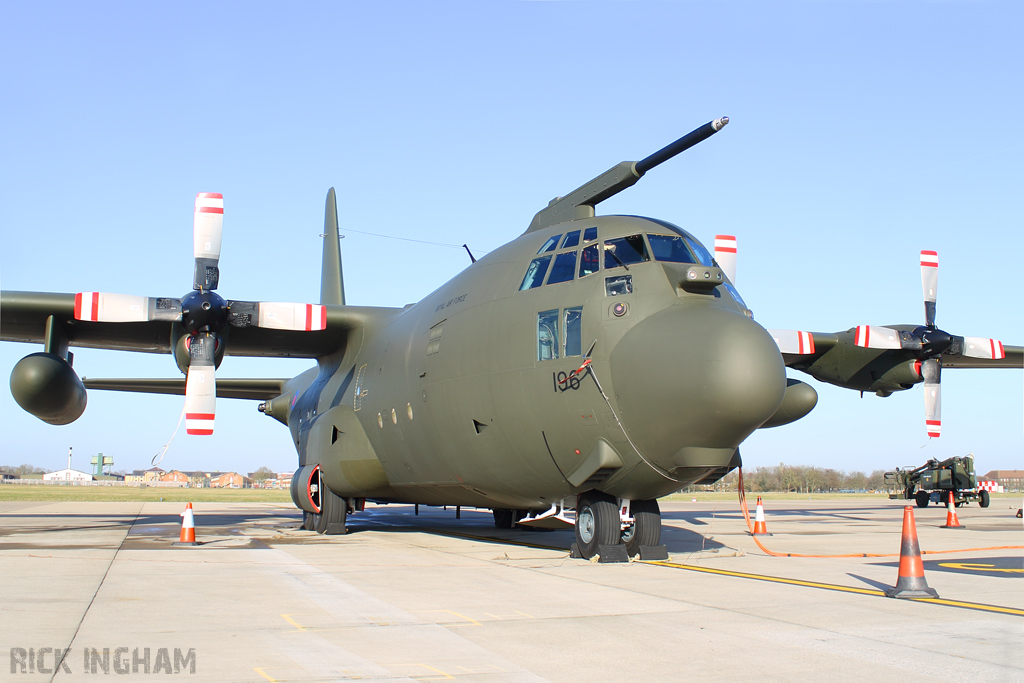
685,463,885,494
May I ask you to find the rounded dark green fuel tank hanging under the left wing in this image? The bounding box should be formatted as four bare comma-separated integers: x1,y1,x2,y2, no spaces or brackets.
10,353,88,425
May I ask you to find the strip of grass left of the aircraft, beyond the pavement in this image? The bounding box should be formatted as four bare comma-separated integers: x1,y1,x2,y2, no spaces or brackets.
0,484,292,503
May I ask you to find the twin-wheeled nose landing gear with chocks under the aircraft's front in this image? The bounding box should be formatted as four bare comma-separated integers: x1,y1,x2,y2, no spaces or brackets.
575,490,668,559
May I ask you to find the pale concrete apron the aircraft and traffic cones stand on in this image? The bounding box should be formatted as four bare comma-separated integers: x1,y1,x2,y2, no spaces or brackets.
0,495,1024,682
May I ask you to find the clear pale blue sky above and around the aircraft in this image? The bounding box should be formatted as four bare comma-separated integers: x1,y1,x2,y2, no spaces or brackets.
0,1,1024,479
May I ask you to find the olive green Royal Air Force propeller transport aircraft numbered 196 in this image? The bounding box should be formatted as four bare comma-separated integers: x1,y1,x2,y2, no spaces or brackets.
0,118,1024,557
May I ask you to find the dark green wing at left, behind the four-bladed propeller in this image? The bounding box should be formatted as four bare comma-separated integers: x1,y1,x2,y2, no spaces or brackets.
0,292,401,358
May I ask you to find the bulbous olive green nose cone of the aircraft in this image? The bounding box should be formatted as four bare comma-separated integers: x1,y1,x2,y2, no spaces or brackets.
610,303,785,478
